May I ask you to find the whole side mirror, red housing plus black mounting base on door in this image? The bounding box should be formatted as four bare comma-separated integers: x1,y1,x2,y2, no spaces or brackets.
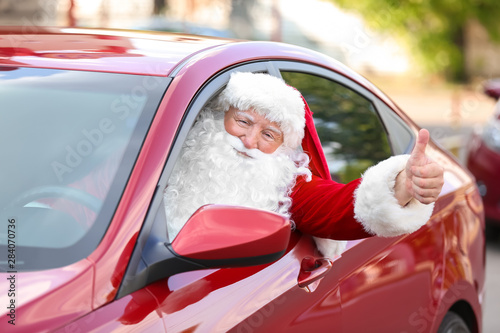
117,205,291,297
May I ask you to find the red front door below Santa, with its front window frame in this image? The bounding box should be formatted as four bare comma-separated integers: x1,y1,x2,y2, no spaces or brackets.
119,62,341,332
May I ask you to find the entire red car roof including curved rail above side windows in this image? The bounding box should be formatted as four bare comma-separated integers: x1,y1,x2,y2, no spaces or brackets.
0,26,397,108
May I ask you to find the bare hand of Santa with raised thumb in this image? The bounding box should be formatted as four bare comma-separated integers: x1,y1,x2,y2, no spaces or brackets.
394,129,444,206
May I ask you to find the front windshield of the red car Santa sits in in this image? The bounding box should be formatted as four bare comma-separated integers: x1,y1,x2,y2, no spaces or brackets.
0,67,168,271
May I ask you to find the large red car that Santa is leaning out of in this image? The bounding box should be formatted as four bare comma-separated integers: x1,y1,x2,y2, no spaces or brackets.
0,27,485,332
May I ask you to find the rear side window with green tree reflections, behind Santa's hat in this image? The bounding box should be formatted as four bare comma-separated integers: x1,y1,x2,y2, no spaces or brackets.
281,71,391,183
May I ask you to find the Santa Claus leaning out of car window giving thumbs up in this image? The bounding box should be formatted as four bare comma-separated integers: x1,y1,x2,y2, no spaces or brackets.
164,73,443,256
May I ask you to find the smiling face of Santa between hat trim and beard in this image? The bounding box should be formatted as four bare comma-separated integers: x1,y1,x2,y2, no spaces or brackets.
224,107,283,154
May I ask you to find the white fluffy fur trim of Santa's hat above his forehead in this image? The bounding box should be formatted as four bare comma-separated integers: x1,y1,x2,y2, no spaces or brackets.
217,72,305,149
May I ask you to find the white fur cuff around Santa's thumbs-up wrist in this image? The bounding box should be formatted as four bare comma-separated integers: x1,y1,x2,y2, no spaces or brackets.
354,155,434,237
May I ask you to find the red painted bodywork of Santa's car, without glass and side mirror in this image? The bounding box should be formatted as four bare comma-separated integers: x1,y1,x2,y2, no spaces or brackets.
0,28,484,332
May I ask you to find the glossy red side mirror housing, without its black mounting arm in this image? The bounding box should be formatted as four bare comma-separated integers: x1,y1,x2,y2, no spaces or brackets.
172,205,290,268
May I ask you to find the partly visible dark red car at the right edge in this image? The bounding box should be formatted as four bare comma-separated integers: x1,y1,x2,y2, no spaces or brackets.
466,79,500,231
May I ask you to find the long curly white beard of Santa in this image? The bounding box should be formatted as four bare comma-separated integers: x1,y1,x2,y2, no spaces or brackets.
164,109,311,240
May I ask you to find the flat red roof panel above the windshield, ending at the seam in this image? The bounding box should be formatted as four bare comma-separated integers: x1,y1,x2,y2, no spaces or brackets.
0,26,236,76
